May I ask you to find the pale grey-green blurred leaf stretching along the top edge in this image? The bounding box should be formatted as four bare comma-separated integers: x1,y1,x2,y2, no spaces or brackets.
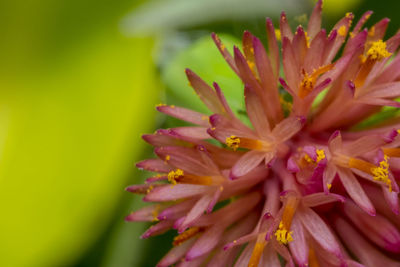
122,0,309,34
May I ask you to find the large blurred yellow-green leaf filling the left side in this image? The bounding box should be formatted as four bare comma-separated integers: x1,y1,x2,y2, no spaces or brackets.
0,1,160,267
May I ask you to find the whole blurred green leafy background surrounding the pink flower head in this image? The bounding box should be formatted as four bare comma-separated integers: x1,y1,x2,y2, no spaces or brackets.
0,0,400,267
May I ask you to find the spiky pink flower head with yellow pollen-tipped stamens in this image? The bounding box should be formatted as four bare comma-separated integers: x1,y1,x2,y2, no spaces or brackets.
126,1,400,267
